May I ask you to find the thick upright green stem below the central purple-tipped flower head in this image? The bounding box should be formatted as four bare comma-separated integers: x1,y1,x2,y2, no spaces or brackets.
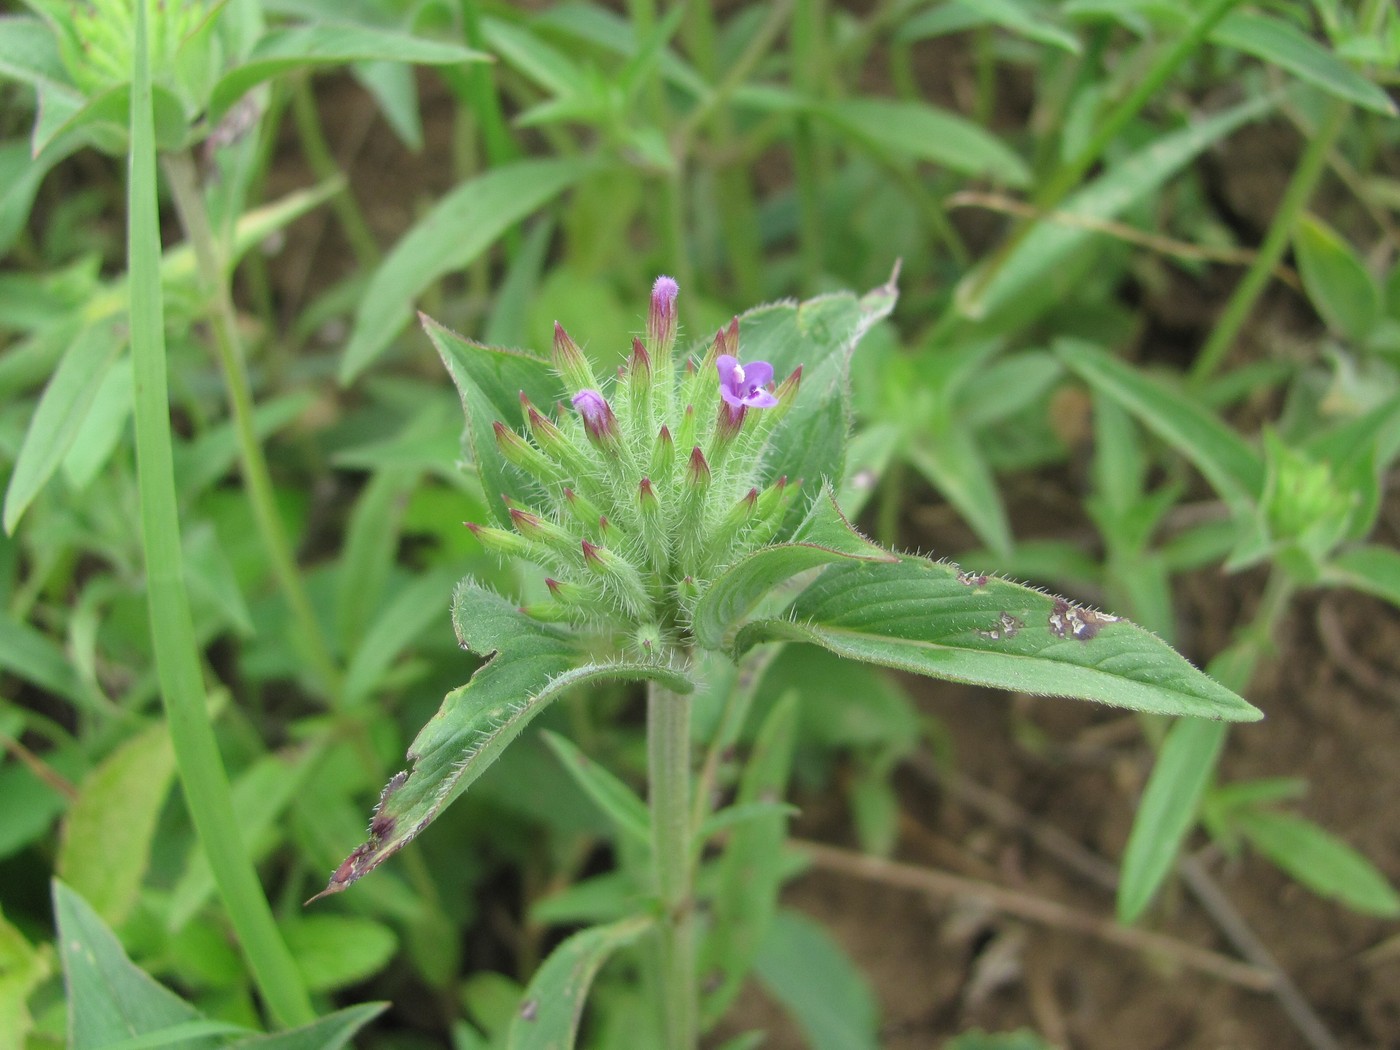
647,666,696,1050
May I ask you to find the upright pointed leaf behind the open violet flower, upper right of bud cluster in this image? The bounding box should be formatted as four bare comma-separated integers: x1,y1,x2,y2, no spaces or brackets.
739,270,899,525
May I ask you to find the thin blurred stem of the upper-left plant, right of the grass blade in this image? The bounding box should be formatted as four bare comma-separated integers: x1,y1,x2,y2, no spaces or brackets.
164,153,340,697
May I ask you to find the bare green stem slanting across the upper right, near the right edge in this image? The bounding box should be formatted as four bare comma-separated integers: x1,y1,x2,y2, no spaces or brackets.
1190,98,1351,385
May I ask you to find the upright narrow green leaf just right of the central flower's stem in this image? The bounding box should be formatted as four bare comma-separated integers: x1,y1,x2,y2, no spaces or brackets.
700,692,801,1023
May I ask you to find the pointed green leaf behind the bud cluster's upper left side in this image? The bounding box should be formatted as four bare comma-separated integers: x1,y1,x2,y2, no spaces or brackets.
423,316,560,528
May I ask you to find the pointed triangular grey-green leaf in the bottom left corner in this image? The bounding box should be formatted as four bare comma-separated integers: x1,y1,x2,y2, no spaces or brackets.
53,879,223,1050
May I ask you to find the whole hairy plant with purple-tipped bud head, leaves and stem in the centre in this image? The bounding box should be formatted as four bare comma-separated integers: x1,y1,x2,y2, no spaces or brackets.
325,277,1259,1050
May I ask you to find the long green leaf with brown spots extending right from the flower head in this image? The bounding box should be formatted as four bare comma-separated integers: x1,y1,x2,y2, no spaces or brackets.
736,557,1261,721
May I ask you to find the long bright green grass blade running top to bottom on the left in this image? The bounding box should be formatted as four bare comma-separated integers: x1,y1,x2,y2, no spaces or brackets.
127,0,315,1026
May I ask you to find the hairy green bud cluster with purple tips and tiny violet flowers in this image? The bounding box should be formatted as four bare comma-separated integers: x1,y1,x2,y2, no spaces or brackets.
469,277,802,650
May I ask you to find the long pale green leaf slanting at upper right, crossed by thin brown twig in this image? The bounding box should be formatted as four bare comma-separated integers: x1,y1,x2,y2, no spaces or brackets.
955,97,1274,319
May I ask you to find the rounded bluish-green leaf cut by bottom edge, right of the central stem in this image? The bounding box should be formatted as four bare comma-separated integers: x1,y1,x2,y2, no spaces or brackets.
757,911,879,1050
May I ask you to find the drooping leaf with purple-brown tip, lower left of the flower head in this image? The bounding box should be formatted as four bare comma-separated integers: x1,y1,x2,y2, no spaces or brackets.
318,580,693,896
